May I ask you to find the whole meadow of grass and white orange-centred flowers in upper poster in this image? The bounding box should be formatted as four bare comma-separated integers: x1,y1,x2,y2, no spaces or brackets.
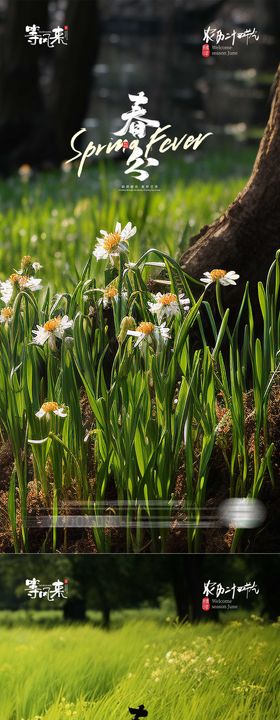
0,145,280,552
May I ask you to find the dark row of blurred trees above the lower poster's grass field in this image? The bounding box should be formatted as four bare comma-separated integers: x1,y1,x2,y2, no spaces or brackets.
0,555,280,628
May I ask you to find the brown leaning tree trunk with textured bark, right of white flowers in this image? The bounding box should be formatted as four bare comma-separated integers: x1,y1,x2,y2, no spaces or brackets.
180,66,280,306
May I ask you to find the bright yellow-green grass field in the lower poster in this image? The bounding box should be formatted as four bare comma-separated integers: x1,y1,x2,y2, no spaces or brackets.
0,611,280,720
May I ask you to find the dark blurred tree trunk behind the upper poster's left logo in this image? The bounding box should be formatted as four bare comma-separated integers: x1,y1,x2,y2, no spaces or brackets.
0,0,99,170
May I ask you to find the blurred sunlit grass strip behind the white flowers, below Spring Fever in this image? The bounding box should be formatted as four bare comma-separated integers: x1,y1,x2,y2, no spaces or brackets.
0,148,255,292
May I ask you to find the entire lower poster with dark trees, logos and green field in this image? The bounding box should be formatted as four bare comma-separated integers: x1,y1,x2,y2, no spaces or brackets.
0,555,280,720
